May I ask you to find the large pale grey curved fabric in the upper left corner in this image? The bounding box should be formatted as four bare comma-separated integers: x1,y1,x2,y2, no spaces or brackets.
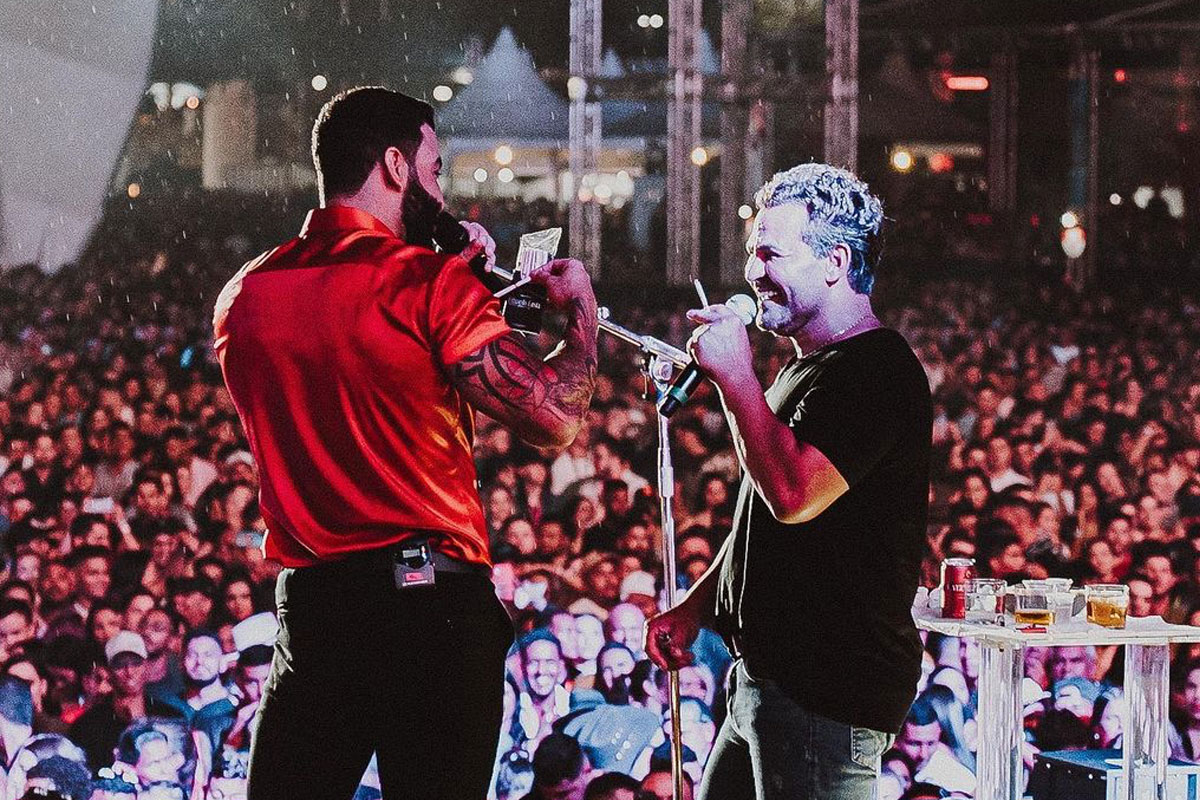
0,0,157,271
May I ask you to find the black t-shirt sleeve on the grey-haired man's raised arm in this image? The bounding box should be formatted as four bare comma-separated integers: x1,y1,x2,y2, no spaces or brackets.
788,350,908,487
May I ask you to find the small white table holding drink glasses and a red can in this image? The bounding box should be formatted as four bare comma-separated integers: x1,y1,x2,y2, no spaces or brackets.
913,609,1200,800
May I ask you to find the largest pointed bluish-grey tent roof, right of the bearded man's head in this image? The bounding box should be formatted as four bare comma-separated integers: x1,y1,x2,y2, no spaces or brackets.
437,28,569,143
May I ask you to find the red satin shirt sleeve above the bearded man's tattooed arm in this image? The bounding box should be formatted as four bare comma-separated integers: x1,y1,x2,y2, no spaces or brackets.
428,257,512,365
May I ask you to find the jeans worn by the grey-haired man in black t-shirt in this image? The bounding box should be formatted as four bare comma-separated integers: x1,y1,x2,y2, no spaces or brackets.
700,661,895,800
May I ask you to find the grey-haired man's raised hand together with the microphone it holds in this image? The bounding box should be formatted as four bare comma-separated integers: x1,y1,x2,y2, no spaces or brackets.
659,294,757,416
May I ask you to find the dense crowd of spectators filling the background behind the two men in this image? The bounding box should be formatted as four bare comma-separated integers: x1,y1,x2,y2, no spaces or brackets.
0,189,1200,800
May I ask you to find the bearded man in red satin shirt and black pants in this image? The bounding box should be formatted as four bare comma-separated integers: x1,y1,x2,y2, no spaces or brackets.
214,88,598,800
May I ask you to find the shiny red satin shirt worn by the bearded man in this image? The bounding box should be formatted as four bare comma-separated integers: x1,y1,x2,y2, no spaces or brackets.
214,206,510,566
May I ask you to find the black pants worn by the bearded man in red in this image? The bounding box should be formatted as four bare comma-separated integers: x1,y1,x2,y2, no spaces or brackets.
248,558,512,800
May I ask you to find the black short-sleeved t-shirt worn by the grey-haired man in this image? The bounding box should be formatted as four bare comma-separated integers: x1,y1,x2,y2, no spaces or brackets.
716,329,932,733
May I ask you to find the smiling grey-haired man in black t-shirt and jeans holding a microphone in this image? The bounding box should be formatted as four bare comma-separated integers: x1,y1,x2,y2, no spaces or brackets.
647,164,932,800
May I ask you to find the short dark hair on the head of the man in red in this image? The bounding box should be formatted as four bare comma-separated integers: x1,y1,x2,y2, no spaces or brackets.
312,86,433,199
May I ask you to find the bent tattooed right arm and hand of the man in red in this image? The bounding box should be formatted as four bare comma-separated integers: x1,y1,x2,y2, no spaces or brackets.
449,259,598,447
